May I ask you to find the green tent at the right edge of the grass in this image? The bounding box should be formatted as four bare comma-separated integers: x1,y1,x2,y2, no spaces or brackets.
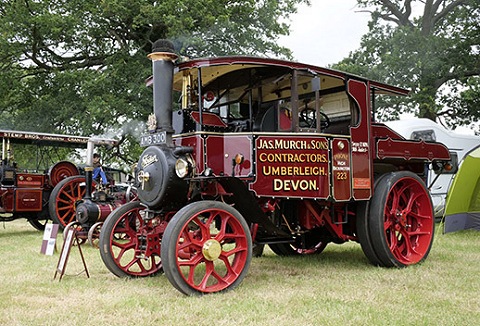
444,146,480,233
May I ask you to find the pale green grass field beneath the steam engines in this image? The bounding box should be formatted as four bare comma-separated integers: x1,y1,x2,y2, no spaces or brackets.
0,220,480,326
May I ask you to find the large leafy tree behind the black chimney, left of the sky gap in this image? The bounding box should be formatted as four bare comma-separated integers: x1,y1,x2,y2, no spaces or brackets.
0,0,309,166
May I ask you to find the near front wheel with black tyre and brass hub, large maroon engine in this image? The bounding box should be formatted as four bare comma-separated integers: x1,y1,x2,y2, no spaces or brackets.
161,201,252,295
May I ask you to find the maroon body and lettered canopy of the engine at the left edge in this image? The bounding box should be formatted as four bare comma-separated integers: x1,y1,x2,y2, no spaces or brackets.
0,130,88,230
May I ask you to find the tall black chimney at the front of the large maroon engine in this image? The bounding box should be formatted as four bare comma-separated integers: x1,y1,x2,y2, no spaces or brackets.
148,40,178,145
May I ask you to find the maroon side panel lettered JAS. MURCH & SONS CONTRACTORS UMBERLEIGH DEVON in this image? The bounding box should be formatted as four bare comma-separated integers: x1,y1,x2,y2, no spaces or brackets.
250,136,329,198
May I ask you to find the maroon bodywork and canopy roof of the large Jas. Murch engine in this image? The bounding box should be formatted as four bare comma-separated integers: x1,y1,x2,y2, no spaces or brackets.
168,56,449,202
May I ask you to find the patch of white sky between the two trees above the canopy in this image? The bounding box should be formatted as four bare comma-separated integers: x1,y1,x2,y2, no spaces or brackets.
279,0,370,67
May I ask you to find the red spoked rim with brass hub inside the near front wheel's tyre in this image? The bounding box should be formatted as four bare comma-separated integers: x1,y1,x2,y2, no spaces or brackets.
175,209,249,293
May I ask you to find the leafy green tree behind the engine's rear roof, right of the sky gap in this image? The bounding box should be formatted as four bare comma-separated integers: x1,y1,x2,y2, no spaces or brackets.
335,0,480,131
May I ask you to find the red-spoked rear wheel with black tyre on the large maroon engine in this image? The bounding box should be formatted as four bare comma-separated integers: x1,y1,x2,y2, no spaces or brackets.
368,171,435,267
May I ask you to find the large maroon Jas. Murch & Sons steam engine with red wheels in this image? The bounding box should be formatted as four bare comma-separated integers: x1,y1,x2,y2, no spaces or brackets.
100,41,450,295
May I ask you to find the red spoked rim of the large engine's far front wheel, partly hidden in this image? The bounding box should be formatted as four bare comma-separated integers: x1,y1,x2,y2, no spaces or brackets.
109,207,164,277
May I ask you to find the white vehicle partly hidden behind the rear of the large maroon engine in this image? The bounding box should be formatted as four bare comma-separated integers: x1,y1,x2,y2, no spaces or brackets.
385,118,480,217
